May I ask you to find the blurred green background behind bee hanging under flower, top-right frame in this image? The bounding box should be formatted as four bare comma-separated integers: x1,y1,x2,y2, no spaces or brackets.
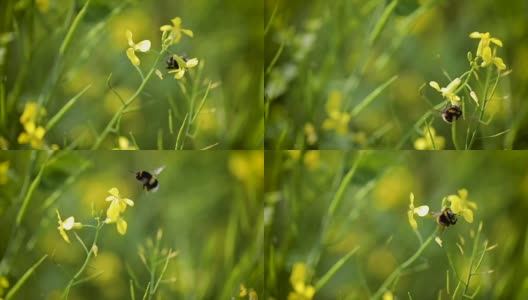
264,0,528,150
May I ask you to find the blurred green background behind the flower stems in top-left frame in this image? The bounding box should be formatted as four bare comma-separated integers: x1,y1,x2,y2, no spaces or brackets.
0,0,263,149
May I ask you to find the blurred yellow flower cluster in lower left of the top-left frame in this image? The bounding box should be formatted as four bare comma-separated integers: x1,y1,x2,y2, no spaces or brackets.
18,102,46,149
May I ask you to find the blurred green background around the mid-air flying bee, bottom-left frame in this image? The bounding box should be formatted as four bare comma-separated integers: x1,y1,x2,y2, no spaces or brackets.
0,151,264,299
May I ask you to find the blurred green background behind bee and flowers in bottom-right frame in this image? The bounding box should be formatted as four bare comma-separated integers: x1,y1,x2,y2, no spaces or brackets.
264,150,528,300
